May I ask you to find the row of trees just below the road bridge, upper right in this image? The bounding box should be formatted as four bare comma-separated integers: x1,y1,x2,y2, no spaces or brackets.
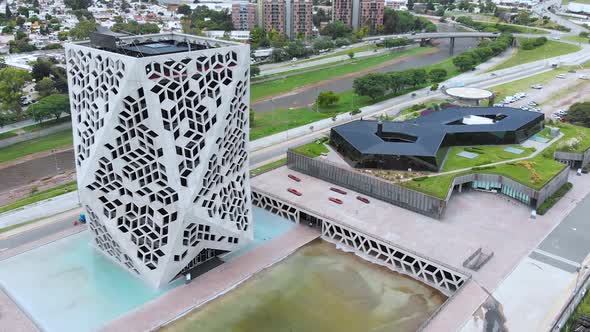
453,34,513,71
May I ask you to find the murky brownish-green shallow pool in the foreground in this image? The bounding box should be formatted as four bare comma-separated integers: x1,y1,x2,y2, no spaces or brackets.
163,240,446,332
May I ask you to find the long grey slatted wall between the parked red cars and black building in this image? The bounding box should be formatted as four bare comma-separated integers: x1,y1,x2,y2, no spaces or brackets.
287,151,446,219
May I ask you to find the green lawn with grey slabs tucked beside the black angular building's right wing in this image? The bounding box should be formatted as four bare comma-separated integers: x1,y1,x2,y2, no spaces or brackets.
442,145,535,172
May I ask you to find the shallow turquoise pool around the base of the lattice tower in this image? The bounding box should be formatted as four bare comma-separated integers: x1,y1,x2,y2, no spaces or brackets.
0,208,294,332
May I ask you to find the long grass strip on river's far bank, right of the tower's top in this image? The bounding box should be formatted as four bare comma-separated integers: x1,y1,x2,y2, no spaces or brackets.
250,47,435,102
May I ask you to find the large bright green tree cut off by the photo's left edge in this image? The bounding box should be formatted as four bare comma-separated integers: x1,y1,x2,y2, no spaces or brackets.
0,67,31,120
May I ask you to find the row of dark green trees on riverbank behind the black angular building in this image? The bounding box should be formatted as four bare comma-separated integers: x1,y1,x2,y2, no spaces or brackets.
352,68,447,100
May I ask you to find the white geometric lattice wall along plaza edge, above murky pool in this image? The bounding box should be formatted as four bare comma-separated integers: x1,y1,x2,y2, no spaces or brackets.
252,187,470,297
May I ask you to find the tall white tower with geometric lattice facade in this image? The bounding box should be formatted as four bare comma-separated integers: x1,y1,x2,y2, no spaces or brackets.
66,34,253,287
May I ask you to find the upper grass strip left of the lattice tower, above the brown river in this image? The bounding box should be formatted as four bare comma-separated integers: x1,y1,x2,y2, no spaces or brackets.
0,129,74,163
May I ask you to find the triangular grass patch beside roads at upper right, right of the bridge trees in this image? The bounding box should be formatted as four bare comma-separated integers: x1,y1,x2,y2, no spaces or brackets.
490,38,580,71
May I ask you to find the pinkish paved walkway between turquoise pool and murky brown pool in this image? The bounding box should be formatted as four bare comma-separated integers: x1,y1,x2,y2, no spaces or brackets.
103,225,320,332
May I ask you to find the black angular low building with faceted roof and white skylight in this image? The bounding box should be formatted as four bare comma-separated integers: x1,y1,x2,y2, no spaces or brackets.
330,107,545,171
